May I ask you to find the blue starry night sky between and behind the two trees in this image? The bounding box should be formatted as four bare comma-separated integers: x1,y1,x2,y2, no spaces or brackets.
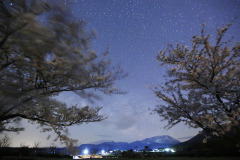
7,0,240,146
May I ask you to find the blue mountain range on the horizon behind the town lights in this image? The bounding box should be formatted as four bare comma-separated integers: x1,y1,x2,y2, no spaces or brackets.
78,135,180,151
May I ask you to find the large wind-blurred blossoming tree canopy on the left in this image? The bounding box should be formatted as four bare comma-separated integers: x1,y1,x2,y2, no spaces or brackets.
0,0,125,145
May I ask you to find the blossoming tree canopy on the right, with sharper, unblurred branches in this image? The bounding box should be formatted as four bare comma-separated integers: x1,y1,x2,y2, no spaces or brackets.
154,24,240,143
